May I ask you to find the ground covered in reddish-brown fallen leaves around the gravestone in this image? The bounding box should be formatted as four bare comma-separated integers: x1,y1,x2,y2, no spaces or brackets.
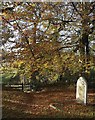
2,87,95,119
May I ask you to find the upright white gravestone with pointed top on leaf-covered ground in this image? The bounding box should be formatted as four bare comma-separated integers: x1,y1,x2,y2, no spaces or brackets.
76,77,87,105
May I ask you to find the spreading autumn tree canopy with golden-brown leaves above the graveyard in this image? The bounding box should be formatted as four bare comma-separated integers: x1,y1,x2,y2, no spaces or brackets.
1,2,95,83
